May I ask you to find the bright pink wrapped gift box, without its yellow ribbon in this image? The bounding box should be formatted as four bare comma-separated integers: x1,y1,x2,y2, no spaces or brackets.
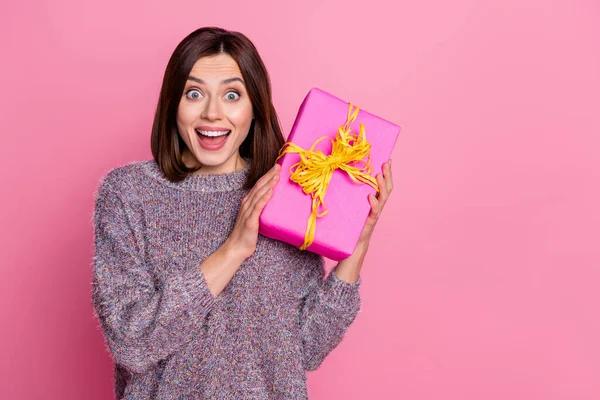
259,88,400,261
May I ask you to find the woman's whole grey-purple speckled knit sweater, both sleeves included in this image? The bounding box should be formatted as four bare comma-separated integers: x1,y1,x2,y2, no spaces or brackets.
92,160,360,400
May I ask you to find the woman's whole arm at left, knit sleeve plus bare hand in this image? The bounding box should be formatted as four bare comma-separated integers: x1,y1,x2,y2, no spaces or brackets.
92,165,279,373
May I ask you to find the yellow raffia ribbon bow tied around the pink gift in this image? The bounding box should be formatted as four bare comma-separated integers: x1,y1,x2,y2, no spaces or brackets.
277,103,379,250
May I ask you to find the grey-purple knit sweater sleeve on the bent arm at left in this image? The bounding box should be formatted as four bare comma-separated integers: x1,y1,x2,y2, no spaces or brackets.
92,175,215,373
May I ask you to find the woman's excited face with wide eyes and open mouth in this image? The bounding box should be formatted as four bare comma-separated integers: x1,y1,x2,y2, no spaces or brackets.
177,54,253,174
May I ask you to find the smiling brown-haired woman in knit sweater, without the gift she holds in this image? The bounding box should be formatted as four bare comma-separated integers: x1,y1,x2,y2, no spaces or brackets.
92,28,392,399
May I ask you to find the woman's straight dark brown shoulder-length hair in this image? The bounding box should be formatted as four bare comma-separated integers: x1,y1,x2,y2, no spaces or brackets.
150,27,284,189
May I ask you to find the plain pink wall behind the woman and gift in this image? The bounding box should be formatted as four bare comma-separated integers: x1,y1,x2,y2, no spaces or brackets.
0,0,600,400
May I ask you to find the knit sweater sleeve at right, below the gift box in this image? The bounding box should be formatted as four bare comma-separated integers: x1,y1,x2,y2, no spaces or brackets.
300,257,361,371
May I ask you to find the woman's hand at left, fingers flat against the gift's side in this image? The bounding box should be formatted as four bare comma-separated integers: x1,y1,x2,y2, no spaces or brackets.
224,164,281,261
